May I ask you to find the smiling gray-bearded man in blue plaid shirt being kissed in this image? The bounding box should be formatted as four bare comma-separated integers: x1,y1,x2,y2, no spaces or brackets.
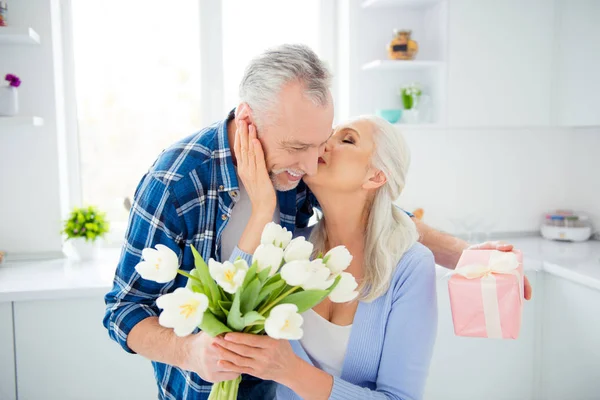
104,45,531,399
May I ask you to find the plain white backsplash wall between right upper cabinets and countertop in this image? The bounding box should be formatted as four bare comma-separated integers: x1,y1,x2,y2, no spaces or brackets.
399,128,600,233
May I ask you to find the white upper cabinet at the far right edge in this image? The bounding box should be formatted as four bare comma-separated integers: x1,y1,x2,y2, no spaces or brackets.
554,0,600,126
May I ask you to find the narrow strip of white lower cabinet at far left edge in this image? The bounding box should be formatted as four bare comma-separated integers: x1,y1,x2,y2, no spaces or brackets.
0,303,17,400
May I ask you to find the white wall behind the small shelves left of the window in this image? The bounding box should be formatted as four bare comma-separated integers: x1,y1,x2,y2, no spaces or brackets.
0,0,66,253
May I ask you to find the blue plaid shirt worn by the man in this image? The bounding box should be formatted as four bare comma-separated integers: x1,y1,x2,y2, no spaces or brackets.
103,113,315,399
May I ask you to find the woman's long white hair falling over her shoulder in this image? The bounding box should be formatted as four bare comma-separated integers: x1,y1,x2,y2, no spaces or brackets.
310,116,418,302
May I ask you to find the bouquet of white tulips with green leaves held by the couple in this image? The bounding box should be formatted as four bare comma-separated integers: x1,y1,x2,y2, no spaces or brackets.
135,223,358,400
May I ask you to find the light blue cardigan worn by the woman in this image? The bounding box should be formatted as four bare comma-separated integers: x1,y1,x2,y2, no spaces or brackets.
230,232,437,400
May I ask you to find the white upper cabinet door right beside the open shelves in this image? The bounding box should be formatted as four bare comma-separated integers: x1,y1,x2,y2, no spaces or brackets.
448,0,555,127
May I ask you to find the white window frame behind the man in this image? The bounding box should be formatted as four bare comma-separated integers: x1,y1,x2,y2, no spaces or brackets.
60,0,345,247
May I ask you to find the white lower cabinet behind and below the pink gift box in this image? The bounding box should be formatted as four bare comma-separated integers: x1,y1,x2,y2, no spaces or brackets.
424,270,541,400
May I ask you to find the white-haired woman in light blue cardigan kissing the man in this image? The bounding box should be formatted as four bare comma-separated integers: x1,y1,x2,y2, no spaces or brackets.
217,116,437,400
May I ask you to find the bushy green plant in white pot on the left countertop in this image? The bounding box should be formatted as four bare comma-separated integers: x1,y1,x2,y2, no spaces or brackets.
62,206,109,260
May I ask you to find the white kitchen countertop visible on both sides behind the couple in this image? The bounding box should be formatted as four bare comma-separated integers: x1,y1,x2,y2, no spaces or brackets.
0,237,600,302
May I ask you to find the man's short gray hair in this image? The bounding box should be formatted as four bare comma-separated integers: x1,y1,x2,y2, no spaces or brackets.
239,44,331,125
